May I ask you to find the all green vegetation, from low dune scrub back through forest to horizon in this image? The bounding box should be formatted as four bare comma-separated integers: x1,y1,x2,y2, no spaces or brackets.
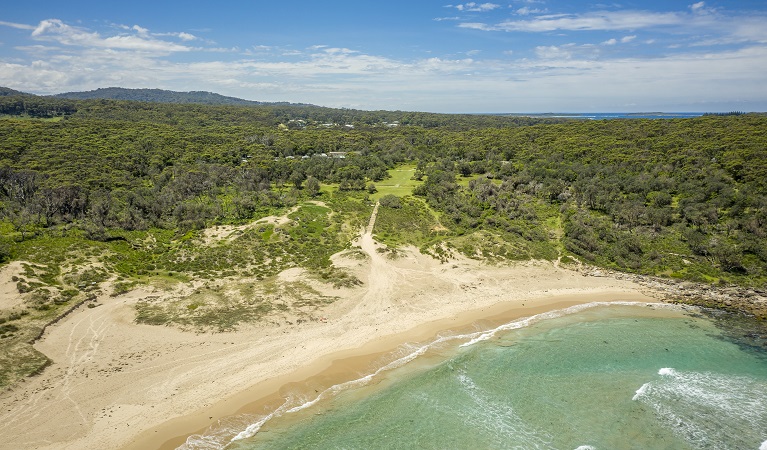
0,89,767,386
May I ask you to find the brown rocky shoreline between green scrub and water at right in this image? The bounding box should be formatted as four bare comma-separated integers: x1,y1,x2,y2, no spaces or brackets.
579,267,767,321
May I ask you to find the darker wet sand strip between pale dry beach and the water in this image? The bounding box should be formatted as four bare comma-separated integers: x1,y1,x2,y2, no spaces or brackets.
129,291,663,450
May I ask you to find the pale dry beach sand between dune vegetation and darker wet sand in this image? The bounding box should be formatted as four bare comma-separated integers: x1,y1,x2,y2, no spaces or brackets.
0,223,654,450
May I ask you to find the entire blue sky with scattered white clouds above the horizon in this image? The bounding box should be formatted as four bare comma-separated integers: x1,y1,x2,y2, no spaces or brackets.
0,0,767,112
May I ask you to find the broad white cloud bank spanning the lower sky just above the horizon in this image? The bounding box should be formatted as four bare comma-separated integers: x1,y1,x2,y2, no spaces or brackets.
0,13,767,112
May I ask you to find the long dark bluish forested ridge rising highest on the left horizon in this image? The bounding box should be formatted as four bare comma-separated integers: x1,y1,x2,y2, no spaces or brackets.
53,87,312,106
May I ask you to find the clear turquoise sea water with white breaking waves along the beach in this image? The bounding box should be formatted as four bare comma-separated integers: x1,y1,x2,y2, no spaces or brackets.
182,306,767,450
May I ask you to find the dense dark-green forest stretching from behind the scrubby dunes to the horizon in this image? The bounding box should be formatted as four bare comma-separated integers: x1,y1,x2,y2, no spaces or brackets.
0,95,767,285
